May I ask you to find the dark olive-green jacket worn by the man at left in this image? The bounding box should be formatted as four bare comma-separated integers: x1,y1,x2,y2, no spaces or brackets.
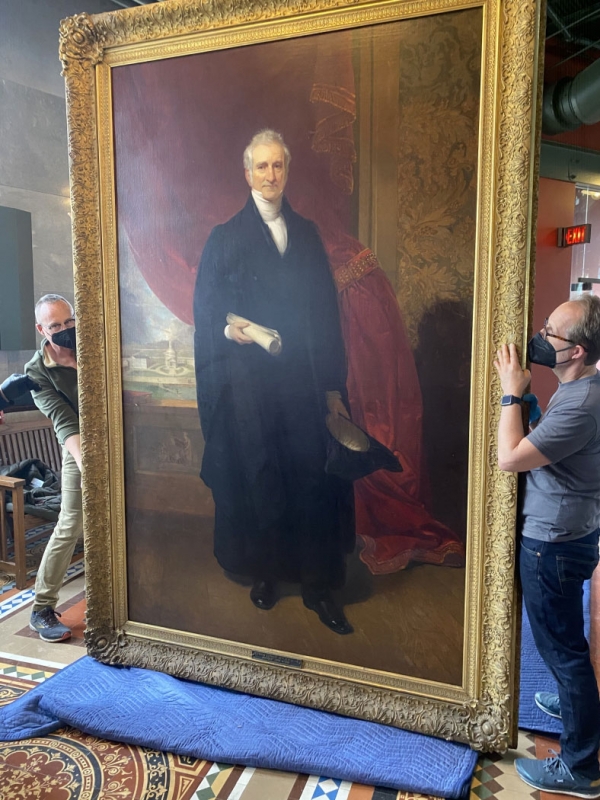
25,339,79,445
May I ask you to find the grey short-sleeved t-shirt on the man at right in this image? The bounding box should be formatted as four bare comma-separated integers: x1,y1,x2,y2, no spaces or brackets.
523,372,600,542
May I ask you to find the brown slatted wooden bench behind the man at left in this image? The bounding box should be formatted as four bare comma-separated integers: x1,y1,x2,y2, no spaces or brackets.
0,411,62,589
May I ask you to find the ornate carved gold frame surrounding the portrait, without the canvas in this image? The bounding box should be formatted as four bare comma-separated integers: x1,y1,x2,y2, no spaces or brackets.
60,0,542,751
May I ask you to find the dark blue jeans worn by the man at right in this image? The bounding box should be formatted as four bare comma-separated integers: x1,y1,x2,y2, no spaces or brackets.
520,529,600,780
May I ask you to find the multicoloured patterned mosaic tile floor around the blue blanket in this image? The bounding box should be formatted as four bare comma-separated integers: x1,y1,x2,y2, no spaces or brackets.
0,572,558,800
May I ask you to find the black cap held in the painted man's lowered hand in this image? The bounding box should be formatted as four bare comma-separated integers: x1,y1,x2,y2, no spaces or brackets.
325,414,402,481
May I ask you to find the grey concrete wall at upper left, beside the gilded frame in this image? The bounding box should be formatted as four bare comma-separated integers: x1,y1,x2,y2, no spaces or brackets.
0,0,117,381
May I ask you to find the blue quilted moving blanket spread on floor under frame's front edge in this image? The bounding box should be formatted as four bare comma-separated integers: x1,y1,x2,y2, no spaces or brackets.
0,656,477,798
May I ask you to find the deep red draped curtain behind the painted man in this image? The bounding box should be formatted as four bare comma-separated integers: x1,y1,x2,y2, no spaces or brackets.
113,32,463,573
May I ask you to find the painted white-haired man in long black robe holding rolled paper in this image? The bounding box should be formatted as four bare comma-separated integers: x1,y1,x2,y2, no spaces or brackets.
194,130,354,634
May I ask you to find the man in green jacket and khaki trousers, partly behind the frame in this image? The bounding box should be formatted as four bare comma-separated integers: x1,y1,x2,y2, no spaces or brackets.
25,294,83,642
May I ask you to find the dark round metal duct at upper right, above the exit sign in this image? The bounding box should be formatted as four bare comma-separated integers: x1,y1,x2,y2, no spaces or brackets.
542,59,600,136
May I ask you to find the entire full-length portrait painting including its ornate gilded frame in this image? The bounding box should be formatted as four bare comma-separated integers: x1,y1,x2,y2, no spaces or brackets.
60,0,540,751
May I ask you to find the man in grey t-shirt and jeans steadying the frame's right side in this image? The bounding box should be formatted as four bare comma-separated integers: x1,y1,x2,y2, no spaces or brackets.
494,295,600,797
